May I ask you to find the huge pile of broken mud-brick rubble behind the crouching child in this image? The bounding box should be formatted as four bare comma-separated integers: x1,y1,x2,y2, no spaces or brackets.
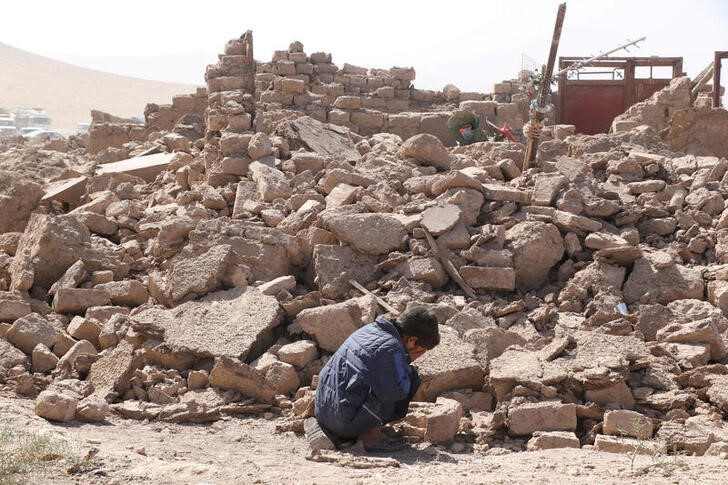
0,36,728,454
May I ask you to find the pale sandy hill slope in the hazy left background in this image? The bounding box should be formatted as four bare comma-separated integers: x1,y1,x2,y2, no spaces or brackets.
0,43,196,134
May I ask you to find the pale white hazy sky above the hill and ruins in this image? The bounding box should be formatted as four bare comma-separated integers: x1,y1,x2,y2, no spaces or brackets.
0,0,728,92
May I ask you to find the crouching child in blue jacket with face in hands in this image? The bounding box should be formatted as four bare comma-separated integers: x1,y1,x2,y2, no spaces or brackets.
304,306,440,451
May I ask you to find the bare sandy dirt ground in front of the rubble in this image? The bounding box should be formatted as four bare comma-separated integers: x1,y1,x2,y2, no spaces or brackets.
0,393,728,484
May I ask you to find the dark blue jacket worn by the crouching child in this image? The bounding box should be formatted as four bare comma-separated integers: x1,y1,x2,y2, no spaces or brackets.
314,317,419,439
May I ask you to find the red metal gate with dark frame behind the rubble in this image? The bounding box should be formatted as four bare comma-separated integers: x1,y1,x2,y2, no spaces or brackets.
556,57,683,135
